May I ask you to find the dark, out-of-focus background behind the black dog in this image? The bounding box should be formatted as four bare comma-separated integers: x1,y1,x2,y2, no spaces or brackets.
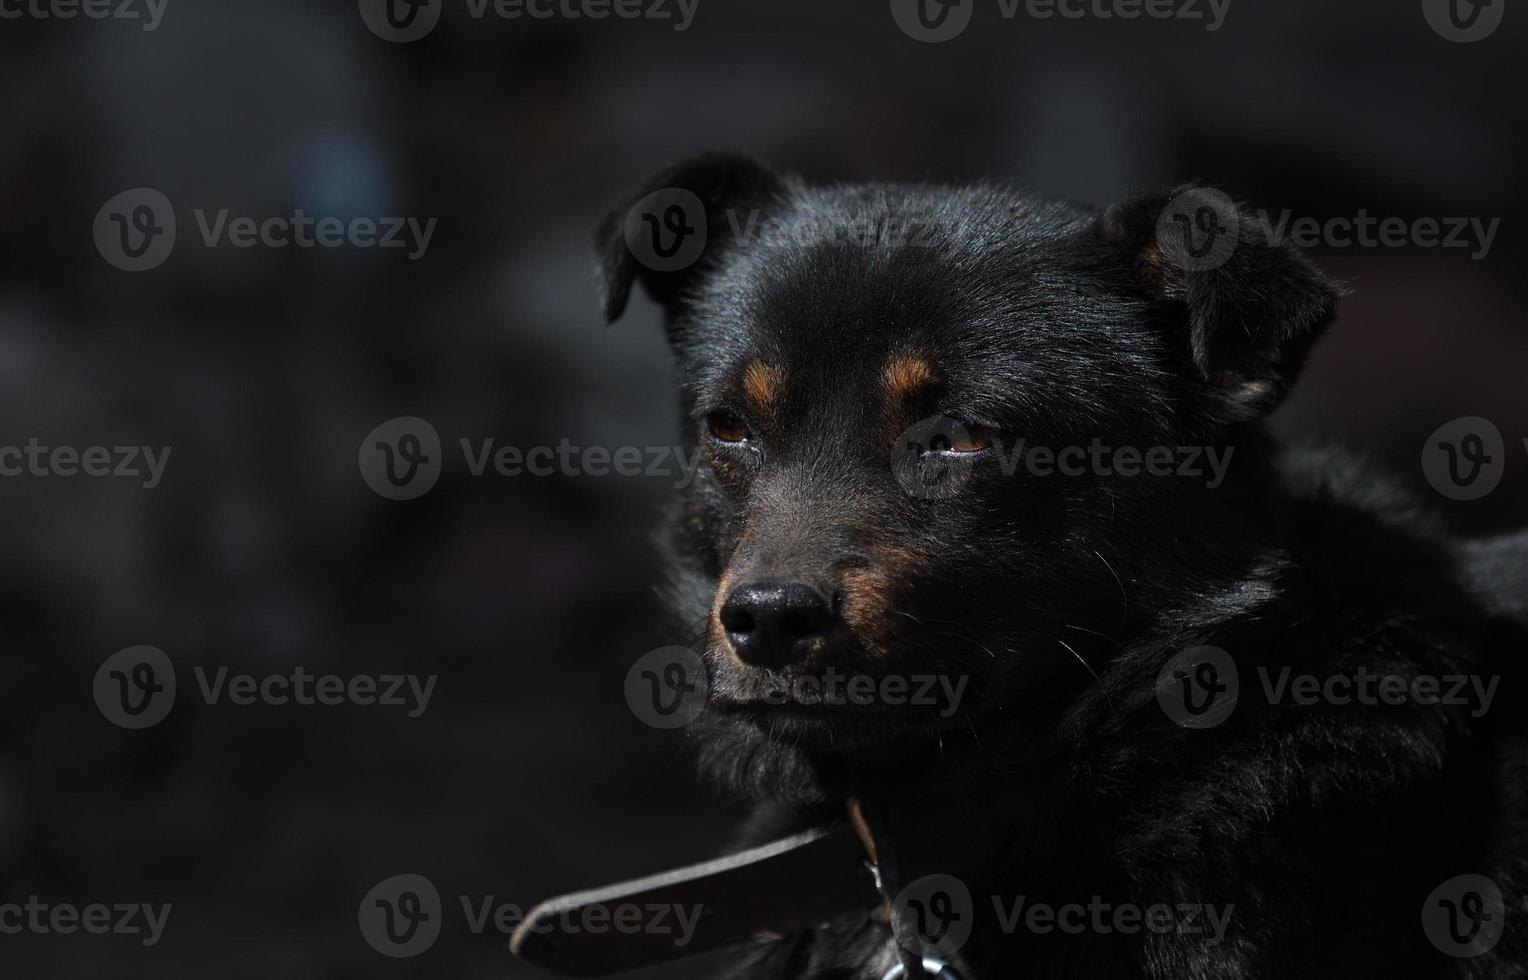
0,0,1528,978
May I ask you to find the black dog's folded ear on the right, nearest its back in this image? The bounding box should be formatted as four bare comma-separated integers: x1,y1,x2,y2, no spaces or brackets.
1102,185,1340,417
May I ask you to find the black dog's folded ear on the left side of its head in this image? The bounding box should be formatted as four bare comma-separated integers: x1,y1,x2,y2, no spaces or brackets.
594,153,785,323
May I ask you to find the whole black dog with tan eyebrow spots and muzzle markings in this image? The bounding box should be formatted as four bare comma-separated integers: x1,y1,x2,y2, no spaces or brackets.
599,154,1528,980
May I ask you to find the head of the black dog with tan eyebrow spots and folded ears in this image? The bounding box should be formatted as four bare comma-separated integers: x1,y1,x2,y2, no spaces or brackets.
597,154,1337,745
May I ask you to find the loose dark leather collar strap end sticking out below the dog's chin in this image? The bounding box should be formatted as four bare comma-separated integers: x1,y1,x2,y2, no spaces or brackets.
509,804,886,977
